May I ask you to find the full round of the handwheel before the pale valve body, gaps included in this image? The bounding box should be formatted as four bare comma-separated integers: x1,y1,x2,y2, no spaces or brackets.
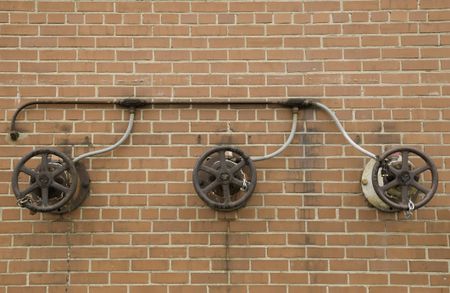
372,147,438,210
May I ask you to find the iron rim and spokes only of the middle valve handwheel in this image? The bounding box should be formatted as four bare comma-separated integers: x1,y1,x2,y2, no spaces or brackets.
192,146,256,211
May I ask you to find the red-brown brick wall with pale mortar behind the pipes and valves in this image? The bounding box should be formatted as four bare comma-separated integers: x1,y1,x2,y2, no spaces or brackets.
0,0,450,293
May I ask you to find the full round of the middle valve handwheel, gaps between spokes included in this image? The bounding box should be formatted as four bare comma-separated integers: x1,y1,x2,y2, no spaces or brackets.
192,146,256,211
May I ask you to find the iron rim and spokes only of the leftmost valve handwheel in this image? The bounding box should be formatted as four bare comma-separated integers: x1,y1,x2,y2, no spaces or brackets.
11,148,78,212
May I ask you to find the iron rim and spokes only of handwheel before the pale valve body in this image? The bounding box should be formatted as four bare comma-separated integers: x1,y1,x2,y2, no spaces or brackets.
372,147,438,210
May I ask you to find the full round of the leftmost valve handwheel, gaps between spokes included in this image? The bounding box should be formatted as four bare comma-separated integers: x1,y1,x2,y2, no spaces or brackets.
11,148,78,212
